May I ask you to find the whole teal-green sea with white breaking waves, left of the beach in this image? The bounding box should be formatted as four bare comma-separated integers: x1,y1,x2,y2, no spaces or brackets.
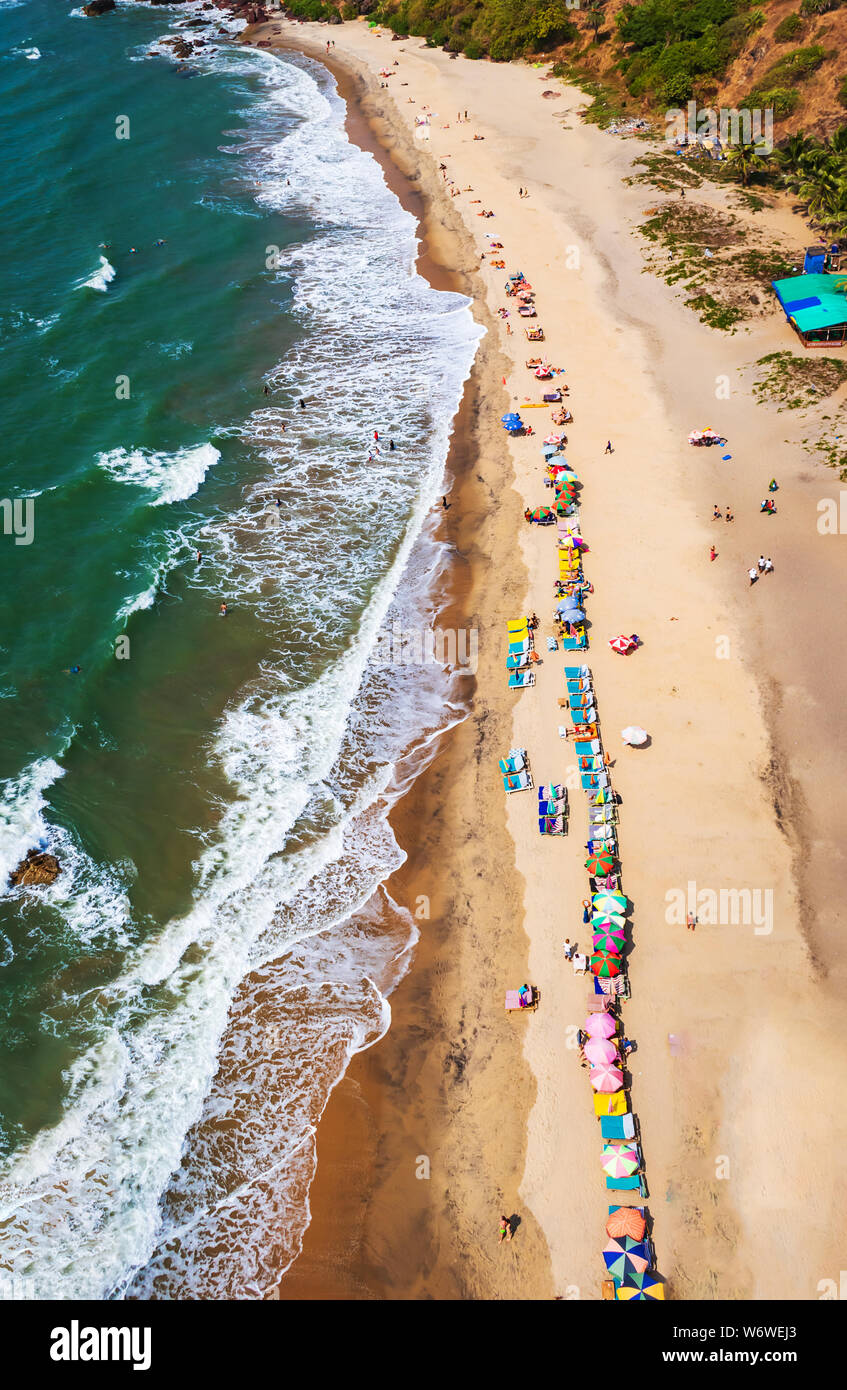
0,0,480,1298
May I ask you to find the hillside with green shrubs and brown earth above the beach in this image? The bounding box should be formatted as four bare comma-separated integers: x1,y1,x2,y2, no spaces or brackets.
288,0,847,138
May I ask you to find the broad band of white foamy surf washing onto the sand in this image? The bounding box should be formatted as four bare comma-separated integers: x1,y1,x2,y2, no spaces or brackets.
0,43,478,1298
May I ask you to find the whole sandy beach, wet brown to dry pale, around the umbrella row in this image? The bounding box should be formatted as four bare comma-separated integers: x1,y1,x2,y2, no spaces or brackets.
245,21,847,1300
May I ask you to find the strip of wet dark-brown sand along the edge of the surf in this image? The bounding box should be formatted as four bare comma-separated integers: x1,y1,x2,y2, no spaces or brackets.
254,27,552,1301
